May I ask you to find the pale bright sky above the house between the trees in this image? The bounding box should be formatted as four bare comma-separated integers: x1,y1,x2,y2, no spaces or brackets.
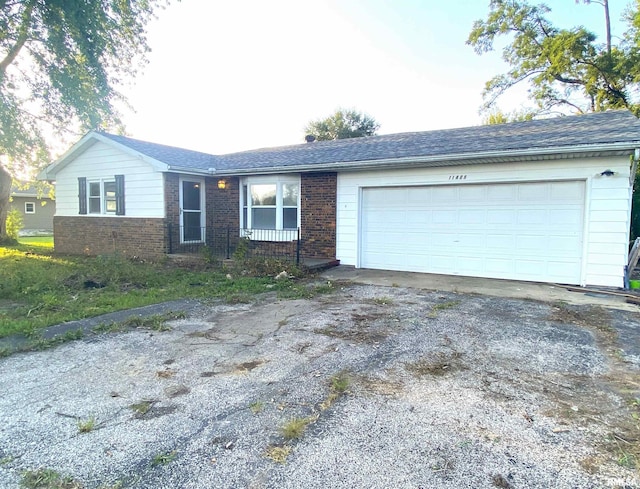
115,0,627,154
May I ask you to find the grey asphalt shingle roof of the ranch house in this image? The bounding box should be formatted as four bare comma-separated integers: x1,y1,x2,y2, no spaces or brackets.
97,110,640,173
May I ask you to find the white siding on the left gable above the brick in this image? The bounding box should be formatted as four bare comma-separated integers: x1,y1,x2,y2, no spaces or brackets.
56,142,165,218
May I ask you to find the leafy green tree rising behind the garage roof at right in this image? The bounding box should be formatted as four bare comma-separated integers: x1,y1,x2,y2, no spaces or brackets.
467,0,640,115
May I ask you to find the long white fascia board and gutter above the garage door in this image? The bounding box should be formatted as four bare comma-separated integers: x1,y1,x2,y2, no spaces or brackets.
216,142,640,176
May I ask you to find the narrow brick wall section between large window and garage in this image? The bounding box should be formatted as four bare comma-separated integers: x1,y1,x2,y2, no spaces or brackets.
300,172,338,258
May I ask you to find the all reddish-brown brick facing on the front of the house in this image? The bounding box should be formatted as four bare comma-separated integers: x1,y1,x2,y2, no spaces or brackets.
54,172,337,259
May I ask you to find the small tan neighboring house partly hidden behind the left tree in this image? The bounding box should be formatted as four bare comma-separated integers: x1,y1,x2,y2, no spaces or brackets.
10,186,56,235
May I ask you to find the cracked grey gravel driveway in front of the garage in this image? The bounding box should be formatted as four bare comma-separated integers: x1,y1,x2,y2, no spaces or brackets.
0,285,640,489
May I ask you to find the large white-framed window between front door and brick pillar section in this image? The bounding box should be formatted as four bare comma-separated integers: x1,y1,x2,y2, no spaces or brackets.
240,177,300,230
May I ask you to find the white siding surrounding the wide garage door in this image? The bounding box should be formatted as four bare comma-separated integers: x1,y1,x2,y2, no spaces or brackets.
336,157,631,287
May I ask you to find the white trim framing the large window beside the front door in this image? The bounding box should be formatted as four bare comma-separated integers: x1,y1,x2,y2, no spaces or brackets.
239,175,302,241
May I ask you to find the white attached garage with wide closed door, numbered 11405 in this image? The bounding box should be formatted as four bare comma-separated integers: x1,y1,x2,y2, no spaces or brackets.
336,147,633,287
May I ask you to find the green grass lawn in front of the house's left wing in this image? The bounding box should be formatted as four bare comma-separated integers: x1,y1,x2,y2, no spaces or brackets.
0,243,322,338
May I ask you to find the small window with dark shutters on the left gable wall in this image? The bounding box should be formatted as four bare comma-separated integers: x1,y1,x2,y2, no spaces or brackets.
78,175,124,216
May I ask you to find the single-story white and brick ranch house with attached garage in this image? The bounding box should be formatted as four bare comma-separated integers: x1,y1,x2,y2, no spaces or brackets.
39,111,640,287
